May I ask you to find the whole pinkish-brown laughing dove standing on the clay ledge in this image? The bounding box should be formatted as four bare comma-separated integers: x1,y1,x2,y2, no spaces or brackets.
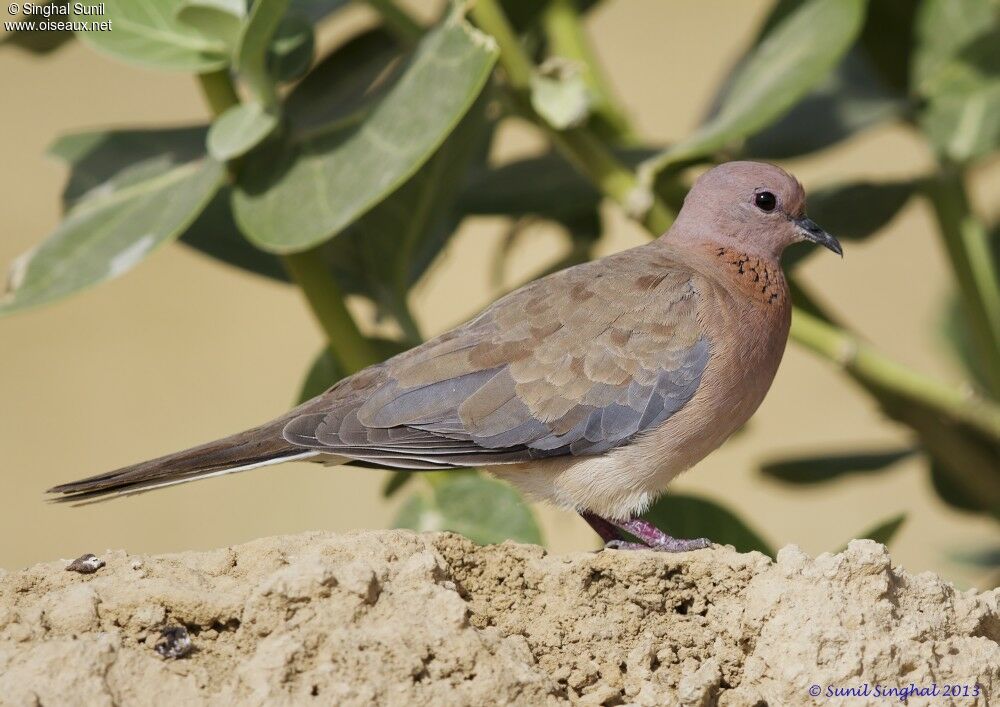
51,162,841,551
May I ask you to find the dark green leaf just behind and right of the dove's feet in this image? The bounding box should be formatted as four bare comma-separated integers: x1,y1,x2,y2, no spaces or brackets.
642,493,774,557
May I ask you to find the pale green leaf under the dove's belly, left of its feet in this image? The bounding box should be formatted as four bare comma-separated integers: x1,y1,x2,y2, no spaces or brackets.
394,471,542,545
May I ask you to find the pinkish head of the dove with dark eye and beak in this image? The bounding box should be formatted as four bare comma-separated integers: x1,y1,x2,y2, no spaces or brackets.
670,162,844,261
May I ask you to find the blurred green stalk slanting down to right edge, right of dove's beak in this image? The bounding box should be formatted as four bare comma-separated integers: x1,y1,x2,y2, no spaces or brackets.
924,171,1000,400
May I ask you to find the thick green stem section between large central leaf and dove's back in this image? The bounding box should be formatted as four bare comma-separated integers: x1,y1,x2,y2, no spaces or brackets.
282,248,380,373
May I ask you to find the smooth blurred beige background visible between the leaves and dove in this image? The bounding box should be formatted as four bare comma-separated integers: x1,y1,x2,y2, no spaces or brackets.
0,0,1000,585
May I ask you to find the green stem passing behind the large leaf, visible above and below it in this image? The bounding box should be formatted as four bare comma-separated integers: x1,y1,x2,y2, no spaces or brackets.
198,69,380,373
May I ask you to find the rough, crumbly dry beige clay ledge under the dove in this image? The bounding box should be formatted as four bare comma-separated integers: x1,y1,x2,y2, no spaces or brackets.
0,531,1000,706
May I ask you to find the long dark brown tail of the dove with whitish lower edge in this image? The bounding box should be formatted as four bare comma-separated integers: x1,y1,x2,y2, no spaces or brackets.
48,422,317,502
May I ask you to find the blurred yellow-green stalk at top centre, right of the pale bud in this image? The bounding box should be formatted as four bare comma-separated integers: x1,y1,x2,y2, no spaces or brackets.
542,0,639,144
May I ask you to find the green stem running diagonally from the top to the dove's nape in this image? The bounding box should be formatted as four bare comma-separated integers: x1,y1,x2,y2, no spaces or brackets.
471,0,674,234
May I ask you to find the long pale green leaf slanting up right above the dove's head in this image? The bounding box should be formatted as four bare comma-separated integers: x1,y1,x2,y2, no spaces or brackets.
642,0,866,177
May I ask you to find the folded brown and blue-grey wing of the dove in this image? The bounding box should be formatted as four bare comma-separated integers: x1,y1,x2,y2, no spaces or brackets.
283,248,710,469
